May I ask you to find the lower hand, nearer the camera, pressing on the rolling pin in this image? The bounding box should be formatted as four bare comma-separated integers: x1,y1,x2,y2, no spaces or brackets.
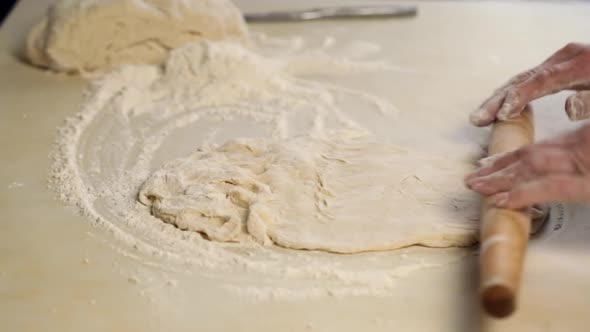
465,124,590,209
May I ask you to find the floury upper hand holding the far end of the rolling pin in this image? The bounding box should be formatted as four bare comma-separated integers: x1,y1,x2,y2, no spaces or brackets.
469,43,590,126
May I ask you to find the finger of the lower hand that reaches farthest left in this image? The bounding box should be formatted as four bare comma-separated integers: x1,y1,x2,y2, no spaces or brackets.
468,147,577,195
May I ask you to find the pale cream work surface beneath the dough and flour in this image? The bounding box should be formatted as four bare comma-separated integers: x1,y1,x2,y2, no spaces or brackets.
0,0,590,331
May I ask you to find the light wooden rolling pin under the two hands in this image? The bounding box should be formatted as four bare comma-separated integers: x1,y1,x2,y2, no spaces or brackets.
479,107,534,318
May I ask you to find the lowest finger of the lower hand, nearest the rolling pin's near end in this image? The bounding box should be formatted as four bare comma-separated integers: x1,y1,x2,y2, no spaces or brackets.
495,174,590,209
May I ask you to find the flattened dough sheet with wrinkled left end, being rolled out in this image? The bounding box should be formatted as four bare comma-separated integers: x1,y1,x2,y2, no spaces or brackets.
139,132,479,253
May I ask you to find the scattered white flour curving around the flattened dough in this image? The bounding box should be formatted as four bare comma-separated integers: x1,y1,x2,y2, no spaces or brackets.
51,38,462,299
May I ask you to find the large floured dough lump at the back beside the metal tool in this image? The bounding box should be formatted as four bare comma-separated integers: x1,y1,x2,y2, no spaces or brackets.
27,0,248,74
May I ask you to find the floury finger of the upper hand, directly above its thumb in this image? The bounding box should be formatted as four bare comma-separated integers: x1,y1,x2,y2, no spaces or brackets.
497,56,590,120
